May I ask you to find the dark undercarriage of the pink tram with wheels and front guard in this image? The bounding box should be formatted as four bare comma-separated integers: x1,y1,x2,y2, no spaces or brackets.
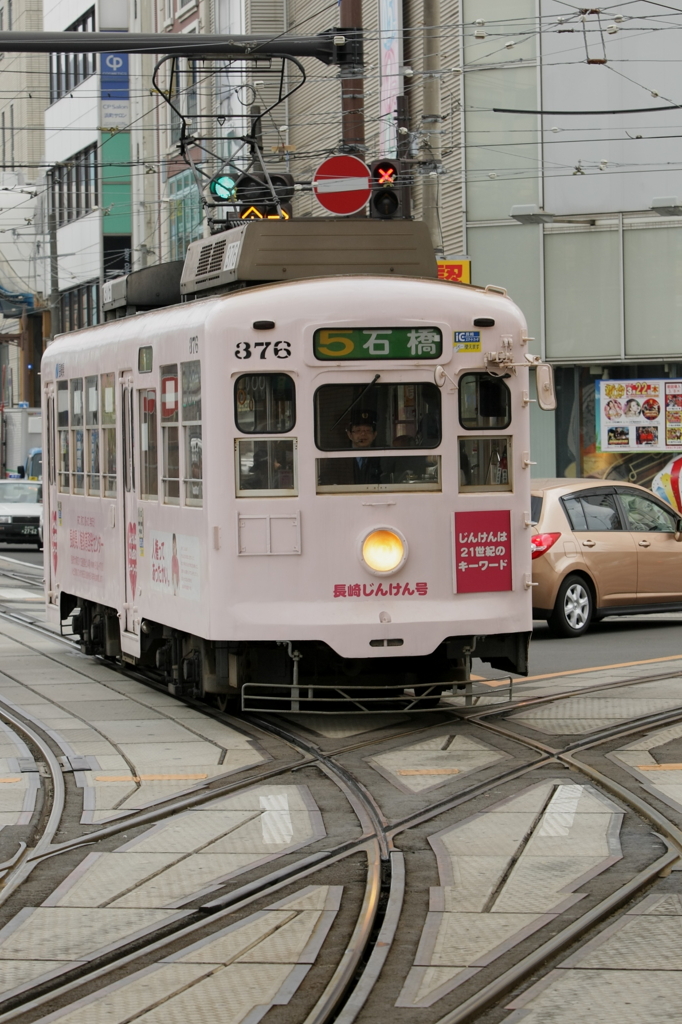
60,593,530,712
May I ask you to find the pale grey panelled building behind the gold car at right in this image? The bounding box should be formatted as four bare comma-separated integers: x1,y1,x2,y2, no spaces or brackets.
462,0,682,484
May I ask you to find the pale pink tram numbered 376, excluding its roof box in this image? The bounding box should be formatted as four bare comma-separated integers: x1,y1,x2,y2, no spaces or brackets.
42,224,552,710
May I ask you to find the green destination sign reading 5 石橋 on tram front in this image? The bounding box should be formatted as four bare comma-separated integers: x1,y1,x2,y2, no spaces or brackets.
312,327,442,361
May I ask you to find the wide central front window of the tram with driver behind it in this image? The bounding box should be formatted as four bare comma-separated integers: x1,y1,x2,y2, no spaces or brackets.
314,378,441,490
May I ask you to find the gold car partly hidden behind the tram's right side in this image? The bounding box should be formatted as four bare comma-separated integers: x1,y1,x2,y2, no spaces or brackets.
530,478,682,637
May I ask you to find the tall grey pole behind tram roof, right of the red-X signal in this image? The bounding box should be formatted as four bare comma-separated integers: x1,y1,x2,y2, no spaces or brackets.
420,0,444,259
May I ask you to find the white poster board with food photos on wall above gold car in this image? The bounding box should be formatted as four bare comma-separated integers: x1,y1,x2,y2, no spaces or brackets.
595,380,682,452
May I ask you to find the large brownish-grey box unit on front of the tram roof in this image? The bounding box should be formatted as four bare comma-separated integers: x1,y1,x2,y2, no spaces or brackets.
180,217,438,295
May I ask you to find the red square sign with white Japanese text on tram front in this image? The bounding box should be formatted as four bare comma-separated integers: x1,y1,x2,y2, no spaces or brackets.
455,510,512,594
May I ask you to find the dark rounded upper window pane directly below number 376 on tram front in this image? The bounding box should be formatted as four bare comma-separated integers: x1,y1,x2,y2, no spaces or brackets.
235,374,296,434
